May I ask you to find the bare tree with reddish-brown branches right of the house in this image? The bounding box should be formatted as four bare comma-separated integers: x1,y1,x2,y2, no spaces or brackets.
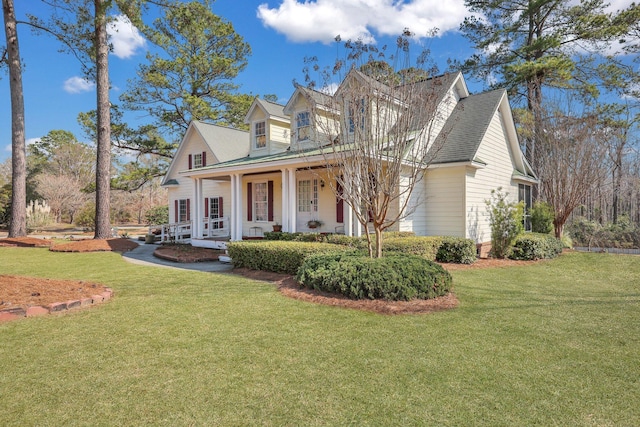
538,101,608,238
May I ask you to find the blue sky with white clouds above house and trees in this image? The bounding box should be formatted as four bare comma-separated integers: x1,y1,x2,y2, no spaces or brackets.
0,0,631,162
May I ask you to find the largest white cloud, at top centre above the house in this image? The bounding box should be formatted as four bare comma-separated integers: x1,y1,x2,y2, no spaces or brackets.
258,0,468,43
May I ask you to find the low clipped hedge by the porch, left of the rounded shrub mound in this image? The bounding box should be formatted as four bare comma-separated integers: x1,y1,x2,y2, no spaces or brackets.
227,241,337,274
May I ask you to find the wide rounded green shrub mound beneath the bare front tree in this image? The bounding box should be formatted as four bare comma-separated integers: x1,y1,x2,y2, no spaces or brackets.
297,253,452,301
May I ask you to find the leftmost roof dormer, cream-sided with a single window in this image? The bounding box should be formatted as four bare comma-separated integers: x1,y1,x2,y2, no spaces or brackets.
244,97,291,157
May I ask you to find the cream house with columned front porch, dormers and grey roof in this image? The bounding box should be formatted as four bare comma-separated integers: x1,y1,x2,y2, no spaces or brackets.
163,70,537,251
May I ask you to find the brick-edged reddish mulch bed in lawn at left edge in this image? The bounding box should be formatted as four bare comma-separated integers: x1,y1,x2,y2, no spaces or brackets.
0,275,106,310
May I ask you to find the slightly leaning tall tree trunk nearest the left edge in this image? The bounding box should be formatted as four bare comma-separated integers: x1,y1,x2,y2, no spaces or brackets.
2,0,27,237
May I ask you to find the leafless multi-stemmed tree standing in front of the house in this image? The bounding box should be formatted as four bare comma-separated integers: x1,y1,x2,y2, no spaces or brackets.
296,33,453,257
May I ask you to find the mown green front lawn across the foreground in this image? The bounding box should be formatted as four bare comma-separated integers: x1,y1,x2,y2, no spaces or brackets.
0,248,640,426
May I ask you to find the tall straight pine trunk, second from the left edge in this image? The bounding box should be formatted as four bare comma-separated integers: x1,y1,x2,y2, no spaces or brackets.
94,0,111,239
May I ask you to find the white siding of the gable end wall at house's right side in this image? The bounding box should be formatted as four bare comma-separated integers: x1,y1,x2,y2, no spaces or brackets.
466,111,518,243
